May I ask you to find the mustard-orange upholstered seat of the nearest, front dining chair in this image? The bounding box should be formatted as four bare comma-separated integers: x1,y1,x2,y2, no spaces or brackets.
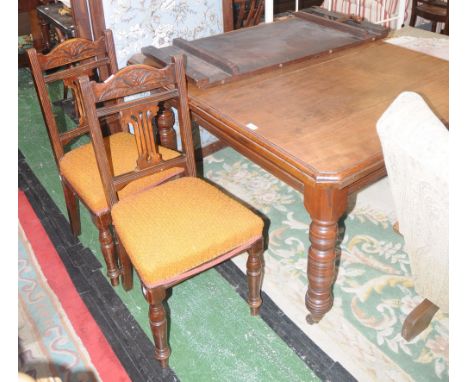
112,177,263,287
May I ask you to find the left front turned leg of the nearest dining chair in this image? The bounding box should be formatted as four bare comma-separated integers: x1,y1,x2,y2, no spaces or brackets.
141,283,171,367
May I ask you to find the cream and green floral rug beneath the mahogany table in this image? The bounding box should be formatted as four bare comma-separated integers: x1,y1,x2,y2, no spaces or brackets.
204,148,448,381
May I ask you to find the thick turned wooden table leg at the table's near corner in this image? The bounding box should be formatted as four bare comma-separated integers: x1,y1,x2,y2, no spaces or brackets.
304,184,347,324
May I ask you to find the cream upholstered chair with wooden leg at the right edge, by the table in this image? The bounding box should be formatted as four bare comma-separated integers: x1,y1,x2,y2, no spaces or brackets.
377,92,449,340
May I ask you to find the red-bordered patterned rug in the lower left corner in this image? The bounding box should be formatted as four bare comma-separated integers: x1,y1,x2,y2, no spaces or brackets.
18,193,130,382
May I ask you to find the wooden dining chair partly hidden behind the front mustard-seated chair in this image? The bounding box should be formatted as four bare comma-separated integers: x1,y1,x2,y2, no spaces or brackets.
27,30,182,286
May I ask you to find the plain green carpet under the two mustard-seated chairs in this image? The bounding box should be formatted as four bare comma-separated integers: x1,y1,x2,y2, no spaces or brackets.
18,69,319,381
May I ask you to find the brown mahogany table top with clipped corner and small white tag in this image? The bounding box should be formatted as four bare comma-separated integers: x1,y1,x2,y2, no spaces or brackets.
189,42,449,187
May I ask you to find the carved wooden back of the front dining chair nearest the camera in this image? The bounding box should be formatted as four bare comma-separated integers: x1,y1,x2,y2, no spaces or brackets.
78,56,196,206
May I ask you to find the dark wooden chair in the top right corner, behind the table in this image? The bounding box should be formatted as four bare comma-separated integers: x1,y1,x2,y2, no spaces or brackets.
410,0,449,35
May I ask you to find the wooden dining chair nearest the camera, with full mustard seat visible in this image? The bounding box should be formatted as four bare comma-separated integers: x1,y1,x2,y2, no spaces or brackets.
79,56,263,367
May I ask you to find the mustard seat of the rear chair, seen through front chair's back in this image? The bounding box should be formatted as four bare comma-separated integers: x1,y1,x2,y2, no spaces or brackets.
59,132,184,214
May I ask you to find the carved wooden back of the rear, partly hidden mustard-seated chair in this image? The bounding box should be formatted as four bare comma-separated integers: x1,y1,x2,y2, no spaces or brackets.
27,30,117,163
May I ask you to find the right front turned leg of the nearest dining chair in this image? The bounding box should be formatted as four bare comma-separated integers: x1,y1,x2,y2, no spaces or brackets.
247,238,263,316
